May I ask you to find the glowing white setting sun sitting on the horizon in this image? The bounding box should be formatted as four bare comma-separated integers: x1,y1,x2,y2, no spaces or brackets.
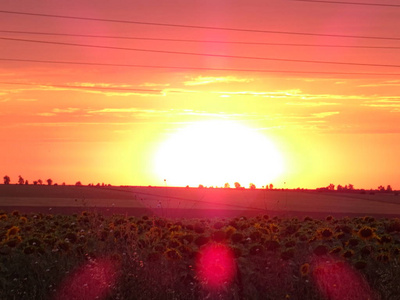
154,121,284,187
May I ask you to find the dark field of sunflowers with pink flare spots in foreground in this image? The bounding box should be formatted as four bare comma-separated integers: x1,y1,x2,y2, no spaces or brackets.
0,211,400,300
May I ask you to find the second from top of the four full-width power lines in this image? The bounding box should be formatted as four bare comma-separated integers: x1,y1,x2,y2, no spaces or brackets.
0,30,400,49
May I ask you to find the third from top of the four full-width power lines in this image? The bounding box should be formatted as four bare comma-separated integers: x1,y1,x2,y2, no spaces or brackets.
0,37,400,68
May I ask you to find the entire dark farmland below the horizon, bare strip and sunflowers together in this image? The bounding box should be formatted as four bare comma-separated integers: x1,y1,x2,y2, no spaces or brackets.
0,185,400,300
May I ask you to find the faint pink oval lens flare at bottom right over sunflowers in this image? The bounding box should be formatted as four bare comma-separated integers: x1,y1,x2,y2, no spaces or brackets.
313,260,373,300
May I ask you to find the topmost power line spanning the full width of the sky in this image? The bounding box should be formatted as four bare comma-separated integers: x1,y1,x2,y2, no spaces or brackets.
0,10,400,41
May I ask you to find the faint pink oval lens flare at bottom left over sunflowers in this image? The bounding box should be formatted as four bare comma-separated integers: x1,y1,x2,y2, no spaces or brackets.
55,259,117,300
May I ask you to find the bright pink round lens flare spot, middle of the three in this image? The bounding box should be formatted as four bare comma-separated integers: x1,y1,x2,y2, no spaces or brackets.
196,244,236,290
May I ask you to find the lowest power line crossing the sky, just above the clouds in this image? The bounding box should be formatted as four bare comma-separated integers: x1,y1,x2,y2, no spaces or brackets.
0,58,400,76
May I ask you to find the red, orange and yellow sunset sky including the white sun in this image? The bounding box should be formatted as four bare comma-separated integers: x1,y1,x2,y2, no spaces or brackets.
0,0,400,189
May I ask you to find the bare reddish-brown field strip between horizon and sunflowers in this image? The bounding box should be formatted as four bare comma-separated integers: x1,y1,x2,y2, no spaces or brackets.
0,185,400,217
